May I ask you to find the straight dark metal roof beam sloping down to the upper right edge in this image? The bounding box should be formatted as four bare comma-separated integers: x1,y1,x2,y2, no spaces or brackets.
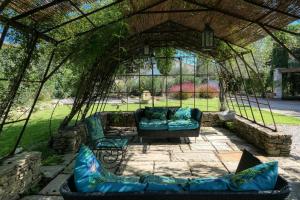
183,0,300,36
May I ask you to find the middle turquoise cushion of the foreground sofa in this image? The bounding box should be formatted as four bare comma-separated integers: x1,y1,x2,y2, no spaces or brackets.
140,175,188,192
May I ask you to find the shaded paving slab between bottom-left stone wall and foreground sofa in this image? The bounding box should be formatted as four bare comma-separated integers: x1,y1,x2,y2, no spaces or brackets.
39,174,70,195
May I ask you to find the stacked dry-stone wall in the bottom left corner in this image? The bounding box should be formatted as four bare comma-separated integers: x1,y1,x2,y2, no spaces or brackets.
0,152,41,200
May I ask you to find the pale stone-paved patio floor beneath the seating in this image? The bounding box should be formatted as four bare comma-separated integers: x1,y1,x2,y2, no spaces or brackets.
23,127,300,200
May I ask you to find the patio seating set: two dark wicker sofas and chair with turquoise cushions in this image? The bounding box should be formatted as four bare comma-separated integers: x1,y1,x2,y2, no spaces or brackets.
60,108,290,200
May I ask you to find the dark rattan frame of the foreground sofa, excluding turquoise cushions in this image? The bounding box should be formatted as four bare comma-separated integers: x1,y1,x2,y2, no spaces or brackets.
60,151,290,200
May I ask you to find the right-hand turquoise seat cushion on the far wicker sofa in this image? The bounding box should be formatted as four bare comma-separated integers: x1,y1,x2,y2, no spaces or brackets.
168,119,199,131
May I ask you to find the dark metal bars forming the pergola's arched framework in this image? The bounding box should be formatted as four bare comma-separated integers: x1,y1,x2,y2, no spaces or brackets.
0,0,300,159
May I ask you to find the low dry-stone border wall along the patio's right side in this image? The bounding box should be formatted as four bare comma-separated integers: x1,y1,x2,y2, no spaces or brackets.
231,117,292,156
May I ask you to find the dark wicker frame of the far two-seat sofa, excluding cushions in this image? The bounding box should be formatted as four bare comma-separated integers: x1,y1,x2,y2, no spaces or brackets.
134,107,202,142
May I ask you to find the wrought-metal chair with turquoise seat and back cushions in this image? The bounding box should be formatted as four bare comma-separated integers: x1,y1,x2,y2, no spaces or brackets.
85,113,128,169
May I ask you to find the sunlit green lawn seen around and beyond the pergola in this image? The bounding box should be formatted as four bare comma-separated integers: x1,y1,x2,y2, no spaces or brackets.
0,98,300,159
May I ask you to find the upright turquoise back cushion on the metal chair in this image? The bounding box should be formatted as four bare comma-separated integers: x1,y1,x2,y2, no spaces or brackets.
85,115,104,143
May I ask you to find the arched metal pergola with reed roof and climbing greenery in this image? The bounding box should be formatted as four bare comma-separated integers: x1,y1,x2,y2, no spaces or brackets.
0,0,300,157
